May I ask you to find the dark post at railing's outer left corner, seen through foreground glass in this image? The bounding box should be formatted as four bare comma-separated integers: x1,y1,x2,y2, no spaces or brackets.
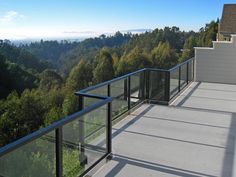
79,95,88,167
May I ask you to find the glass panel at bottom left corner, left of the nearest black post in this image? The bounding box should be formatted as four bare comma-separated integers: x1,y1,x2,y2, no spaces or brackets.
0,131,56,177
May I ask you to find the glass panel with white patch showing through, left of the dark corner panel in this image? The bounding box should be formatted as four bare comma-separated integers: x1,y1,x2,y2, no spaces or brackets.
130,72,145,107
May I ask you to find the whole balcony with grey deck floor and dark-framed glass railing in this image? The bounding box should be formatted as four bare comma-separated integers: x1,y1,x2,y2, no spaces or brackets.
0,36,236,177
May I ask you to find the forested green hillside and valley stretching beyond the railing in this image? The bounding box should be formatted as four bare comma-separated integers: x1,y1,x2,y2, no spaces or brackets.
0,21,218,147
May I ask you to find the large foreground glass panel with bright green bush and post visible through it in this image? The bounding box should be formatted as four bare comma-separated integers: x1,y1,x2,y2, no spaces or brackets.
63,105,107,177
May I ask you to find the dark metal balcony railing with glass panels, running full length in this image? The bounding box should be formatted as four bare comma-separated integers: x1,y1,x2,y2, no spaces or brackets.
0,58,194,177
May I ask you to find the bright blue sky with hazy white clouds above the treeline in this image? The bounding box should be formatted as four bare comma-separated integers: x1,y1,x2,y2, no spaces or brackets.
0,0,236,39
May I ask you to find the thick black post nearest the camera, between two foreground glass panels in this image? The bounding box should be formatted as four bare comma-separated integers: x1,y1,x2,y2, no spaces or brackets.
55,127,63,177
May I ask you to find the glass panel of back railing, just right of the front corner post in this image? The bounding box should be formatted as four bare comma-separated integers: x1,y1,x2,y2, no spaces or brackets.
110,78,128,119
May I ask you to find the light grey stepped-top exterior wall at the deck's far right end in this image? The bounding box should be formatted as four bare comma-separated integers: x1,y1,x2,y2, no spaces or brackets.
195,36,236,84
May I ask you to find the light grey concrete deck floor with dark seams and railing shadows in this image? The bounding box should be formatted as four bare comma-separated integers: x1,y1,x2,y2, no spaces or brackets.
94,83,236,177
